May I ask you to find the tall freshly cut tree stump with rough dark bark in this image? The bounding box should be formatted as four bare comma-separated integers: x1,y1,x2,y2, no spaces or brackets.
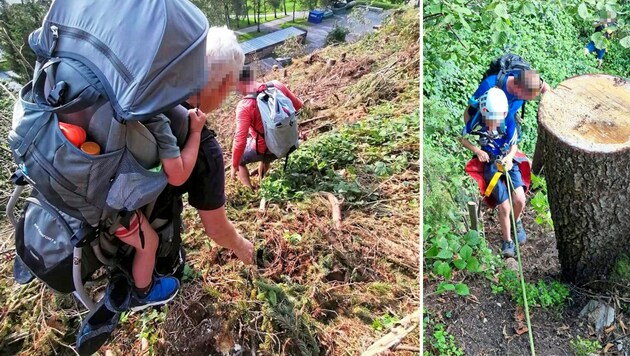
537,74,630,284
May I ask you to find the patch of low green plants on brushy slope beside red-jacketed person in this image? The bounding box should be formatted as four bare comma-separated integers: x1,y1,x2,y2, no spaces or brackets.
261,108,420,202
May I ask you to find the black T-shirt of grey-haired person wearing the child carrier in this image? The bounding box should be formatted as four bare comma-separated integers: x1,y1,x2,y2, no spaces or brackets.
156,126,225,213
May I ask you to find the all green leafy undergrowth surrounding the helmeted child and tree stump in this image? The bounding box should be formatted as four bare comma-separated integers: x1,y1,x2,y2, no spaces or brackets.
422,0,630,355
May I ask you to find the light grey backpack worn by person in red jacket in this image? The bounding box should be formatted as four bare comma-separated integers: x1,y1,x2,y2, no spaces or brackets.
250,82,300,168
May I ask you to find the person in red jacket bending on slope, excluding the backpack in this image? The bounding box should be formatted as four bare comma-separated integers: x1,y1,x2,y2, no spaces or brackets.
230,66,302,190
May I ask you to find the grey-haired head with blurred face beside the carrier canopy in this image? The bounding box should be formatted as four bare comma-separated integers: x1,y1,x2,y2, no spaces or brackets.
199,26,245,112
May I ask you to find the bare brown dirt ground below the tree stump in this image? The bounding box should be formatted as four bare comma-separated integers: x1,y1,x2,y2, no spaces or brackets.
424,208,628,356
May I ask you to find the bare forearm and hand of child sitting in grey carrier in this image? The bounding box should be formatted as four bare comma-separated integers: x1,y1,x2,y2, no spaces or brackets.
162,109,206,186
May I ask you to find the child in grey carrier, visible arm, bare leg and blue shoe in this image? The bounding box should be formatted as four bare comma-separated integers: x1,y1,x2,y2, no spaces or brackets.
115,109,206,311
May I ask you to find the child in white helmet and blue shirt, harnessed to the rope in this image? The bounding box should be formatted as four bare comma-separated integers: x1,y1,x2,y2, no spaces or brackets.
460,87,526,257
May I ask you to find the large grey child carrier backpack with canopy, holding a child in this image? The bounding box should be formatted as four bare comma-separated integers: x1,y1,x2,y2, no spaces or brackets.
9,0,208,292
